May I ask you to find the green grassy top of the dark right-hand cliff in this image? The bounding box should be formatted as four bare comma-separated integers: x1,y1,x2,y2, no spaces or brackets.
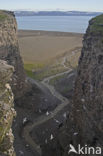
90,15,103,33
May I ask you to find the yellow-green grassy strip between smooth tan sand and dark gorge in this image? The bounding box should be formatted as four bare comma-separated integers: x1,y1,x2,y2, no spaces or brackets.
24,48,80,80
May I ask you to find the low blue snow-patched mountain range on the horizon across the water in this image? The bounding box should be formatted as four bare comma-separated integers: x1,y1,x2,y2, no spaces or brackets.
14,10,102,16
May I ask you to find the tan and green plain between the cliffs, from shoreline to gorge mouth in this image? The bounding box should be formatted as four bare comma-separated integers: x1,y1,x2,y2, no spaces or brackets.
19,31,82,80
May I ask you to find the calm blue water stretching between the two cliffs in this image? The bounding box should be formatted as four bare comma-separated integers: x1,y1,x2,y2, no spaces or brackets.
16,16,93,33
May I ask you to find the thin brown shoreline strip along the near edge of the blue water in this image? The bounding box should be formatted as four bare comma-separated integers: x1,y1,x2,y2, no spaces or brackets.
18,30,84,38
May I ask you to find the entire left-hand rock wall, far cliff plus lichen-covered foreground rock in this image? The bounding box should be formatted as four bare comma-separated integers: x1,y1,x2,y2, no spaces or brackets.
0,11,28,156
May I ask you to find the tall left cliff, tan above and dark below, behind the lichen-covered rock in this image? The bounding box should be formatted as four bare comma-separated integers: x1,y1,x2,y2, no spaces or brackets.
0,11,27,99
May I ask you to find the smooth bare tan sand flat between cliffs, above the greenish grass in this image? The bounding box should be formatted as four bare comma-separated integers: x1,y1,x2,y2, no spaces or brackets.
18,30,83,62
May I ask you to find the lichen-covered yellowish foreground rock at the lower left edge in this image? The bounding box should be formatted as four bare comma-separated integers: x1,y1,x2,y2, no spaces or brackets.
0,60,16,156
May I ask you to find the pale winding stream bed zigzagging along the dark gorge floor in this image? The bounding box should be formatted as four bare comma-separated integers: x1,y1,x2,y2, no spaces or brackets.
23,54,74,156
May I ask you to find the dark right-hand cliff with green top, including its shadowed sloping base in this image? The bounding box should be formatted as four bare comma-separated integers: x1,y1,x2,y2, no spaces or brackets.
43,15,103,156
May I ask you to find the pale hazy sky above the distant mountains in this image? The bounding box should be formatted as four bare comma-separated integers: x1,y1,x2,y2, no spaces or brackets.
0,0,103,12
